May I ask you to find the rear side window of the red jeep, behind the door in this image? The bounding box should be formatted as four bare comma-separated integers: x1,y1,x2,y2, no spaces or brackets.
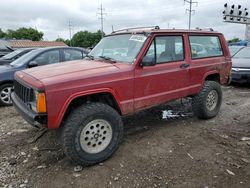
189,36,223,59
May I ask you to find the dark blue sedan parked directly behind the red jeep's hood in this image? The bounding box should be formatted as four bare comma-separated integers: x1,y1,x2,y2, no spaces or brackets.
0,47,87,106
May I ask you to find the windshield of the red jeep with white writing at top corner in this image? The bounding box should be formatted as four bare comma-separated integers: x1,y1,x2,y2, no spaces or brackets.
89,34,146,63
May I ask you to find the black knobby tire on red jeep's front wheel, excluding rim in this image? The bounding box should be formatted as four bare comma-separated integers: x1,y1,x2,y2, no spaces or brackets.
62,103,123,166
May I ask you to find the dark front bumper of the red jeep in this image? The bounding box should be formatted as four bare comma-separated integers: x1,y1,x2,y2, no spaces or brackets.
11,92,47,128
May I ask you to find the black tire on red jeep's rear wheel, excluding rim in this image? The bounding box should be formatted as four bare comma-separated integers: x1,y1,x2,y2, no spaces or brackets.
192,81,222,119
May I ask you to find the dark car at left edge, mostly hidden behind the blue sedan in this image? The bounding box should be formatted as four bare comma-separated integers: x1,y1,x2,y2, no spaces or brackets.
0,48,34,65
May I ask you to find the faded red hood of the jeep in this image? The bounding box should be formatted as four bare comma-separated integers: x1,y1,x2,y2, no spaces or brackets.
21,60,124,82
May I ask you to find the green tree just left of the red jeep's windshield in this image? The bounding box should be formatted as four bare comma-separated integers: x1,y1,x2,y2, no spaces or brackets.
71,30,102,48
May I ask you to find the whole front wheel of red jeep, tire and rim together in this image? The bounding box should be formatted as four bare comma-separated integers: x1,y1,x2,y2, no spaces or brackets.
62,103,123,166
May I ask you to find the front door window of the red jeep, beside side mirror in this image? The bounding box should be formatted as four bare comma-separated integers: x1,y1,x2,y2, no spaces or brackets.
146,36,184,63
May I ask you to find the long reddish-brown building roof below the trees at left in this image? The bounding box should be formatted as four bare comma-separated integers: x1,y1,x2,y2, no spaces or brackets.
9,40,68,48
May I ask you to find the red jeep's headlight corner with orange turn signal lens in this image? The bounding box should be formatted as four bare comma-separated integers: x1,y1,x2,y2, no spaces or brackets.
30,90,47,113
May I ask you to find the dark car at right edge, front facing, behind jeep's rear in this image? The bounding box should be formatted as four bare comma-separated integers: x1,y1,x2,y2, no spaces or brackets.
231,47,250,83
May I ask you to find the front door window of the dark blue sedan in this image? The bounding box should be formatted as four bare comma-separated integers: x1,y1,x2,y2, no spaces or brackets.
34,50,60,66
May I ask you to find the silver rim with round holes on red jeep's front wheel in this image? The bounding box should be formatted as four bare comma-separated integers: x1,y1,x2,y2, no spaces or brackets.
80,119,113,154
